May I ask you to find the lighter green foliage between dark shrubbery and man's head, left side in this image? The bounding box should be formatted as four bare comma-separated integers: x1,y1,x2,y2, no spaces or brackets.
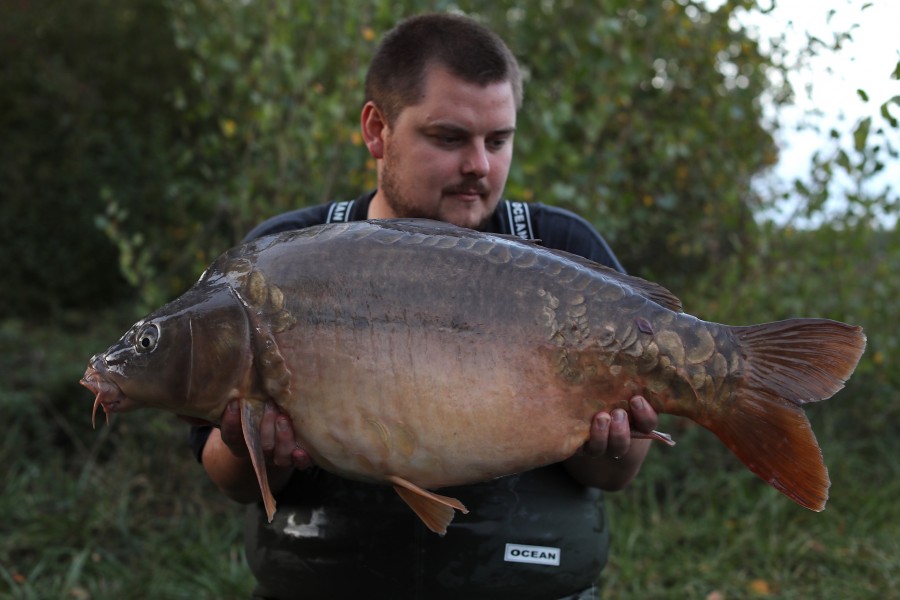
163,0,375,223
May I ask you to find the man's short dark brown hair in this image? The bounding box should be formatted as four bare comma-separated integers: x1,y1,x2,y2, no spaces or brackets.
366,13,522,123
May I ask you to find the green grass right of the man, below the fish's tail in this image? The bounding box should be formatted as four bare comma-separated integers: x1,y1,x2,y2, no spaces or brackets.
604,404,900,600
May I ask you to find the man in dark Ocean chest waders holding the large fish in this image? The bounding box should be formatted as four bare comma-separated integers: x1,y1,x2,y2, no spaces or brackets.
192,15,657,599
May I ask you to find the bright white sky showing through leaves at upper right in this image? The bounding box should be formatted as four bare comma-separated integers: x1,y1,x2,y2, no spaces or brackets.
728,0,900,224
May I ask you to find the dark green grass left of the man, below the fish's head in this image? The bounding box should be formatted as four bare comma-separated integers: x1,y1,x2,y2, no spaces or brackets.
0,312,252,600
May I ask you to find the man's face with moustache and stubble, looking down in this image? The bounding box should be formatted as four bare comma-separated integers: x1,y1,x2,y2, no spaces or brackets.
370,67,516,229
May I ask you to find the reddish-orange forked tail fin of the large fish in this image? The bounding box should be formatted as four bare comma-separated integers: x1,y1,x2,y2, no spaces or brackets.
703,319,866,512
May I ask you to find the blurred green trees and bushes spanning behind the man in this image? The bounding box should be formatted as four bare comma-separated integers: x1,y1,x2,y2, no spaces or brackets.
0,0,896,313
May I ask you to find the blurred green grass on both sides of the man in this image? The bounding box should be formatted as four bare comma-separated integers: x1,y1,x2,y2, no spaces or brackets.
0,313,900,600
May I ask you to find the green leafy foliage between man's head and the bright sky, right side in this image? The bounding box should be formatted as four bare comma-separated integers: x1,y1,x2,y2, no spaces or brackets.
492,0,785,278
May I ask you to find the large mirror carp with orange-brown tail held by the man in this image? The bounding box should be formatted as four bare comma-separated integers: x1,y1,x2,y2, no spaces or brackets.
82,220,865,533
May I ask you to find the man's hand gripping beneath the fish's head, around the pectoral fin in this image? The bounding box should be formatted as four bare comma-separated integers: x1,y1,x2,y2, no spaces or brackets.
220,400,313,469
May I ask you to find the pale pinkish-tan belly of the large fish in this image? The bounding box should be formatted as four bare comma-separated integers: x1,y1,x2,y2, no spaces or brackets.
274,326,592,488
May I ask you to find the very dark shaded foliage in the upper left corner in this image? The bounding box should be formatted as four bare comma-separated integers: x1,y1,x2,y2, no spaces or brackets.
0,0,204,315
